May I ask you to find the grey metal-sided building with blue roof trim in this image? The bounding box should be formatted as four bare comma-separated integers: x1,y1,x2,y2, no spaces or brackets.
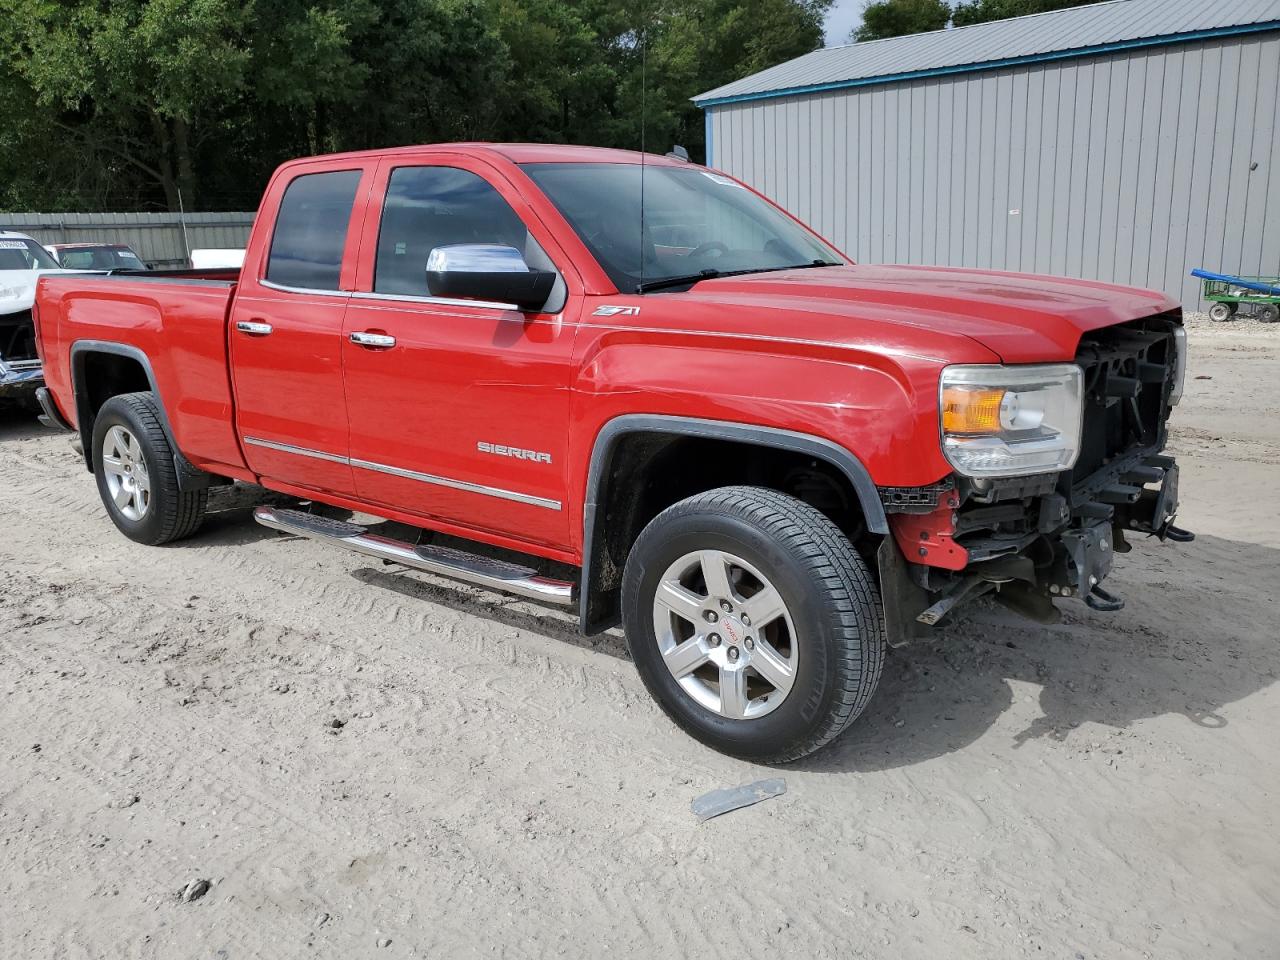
694,0,1280,308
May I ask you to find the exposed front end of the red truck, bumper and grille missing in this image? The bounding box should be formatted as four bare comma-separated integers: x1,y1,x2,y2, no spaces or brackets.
879,312,1193,643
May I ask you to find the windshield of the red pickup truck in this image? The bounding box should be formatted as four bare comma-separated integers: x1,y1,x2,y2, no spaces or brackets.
522,164,845,293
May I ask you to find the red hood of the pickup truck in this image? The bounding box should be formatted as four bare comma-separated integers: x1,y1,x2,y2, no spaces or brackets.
686,265,1179,364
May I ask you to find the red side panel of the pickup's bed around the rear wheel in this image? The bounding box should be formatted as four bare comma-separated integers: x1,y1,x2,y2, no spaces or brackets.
36,269,244,475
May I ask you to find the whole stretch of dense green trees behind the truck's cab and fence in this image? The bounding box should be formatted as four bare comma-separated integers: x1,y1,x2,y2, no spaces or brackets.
0,0,831,210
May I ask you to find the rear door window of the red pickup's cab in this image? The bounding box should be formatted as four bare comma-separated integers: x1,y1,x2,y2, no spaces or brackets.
266,170,360,291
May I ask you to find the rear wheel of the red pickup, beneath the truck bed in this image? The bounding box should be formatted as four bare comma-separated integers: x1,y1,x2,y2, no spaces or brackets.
93,393,209,547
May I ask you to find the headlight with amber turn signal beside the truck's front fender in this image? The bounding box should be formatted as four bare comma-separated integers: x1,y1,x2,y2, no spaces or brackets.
938,364,1083,477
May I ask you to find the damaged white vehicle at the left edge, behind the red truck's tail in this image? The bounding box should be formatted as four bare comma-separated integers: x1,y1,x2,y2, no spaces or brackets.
0,230,77,401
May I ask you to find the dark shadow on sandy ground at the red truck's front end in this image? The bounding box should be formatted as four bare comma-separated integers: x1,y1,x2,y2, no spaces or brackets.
795,536,1280,773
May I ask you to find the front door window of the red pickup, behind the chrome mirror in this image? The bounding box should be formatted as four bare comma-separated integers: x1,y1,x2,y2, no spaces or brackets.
374,166,556,297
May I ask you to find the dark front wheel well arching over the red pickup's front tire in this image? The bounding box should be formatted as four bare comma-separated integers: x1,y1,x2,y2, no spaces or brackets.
582,431,879,631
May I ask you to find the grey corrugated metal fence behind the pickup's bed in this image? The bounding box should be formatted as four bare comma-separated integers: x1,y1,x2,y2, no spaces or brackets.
0,212,253,266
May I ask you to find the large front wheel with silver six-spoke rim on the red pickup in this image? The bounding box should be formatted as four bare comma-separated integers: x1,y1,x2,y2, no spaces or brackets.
622,486,884,763
